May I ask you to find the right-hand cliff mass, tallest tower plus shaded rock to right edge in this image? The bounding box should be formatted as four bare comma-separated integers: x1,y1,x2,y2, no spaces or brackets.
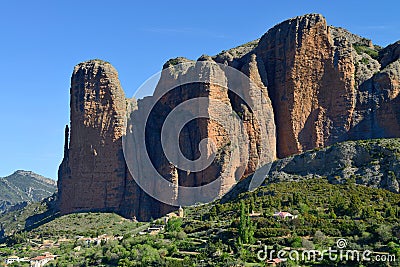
230,14,400,158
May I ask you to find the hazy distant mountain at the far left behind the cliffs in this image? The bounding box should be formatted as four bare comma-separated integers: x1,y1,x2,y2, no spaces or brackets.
0,170,57,213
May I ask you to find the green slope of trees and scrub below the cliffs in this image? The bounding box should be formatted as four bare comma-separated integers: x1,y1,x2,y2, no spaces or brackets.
0,179,400,266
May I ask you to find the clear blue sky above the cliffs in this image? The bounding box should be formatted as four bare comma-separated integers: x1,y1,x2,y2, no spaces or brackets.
0,0,400,179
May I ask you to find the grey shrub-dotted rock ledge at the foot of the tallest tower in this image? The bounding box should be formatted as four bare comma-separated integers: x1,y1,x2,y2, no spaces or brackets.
221,138,400,203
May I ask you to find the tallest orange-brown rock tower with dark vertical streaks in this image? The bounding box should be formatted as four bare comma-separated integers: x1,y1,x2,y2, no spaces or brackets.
256,15,354,157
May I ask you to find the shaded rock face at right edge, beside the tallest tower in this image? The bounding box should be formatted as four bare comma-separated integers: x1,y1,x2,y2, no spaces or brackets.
349,42,400,140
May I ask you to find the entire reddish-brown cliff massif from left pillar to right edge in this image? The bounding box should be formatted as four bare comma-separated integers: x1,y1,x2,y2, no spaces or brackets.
58,14,400,220
